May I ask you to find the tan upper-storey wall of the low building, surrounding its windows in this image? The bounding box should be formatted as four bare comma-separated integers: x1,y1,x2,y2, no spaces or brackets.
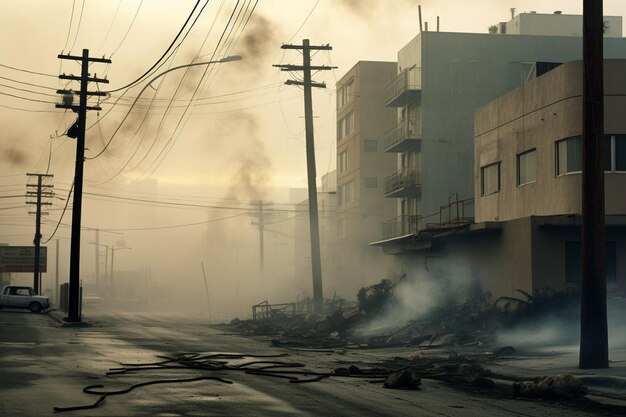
473,60,626,222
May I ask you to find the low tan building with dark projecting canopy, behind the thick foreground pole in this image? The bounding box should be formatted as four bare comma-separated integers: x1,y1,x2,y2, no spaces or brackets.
372,60,626,299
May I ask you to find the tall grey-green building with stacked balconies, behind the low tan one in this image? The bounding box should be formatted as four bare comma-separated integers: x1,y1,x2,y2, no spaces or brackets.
376,14,626,246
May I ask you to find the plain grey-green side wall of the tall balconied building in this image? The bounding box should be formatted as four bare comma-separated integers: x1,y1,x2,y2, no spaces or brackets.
389,32,626,228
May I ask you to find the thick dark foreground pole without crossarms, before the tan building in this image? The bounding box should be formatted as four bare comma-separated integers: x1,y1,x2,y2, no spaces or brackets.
579,0,609,369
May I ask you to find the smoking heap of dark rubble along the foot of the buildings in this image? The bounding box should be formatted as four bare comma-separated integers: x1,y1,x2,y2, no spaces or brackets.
228,277,596,349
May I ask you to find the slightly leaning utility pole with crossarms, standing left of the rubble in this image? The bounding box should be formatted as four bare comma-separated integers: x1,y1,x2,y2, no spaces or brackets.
274,39,336,314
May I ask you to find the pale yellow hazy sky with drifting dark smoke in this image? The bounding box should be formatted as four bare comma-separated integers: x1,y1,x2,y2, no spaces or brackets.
0,0,626,312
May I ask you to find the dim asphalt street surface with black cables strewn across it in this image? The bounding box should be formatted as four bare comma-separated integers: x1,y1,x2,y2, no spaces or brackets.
0,310,620,417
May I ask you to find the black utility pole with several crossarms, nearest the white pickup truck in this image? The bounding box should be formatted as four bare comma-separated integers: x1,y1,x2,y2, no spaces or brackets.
56,49,111,322
